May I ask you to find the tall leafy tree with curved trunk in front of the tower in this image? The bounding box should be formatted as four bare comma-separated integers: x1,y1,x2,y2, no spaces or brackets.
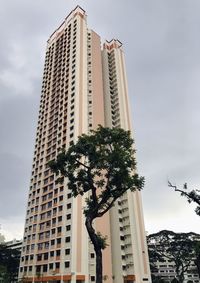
49,126,144,283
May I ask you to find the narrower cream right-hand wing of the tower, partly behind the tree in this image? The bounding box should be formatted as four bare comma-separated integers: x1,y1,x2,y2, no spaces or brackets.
102,40,151,283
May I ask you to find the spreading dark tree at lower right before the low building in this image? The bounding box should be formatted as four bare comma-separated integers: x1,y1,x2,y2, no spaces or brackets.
148,230,195,283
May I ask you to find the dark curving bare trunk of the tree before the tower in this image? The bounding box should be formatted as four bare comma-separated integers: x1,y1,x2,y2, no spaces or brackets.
85,217,103,283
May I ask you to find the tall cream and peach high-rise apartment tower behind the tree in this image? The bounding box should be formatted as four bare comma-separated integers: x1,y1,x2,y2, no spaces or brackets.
19,6,151,283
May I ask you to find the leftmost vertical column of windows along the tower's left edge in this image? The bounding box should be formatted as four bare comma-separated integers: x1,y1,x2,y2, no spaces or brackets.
20,43,53,275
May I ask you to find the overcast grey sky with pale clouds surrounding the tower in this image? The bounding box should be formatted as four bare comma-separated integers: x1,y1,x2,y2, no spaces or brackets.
0,0,200,240
